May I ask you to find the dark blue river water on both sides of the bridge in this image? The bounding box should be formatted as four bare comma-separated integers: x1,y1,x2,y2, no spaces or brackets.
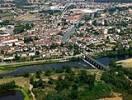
0,57,130,77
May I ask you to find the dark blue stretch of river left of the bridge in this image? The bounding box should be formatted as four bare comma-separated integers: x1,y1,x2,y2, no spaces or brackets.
0,60,91,77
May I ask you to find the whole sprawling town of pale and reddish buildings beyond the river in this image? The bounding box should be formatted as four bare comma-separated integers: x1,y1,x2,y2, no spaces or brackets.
0,0,132,62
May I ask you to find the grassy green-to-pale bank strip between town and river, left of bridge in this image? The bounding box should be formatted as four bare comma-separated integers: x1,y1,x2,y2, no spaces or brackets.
0,55,82,73
